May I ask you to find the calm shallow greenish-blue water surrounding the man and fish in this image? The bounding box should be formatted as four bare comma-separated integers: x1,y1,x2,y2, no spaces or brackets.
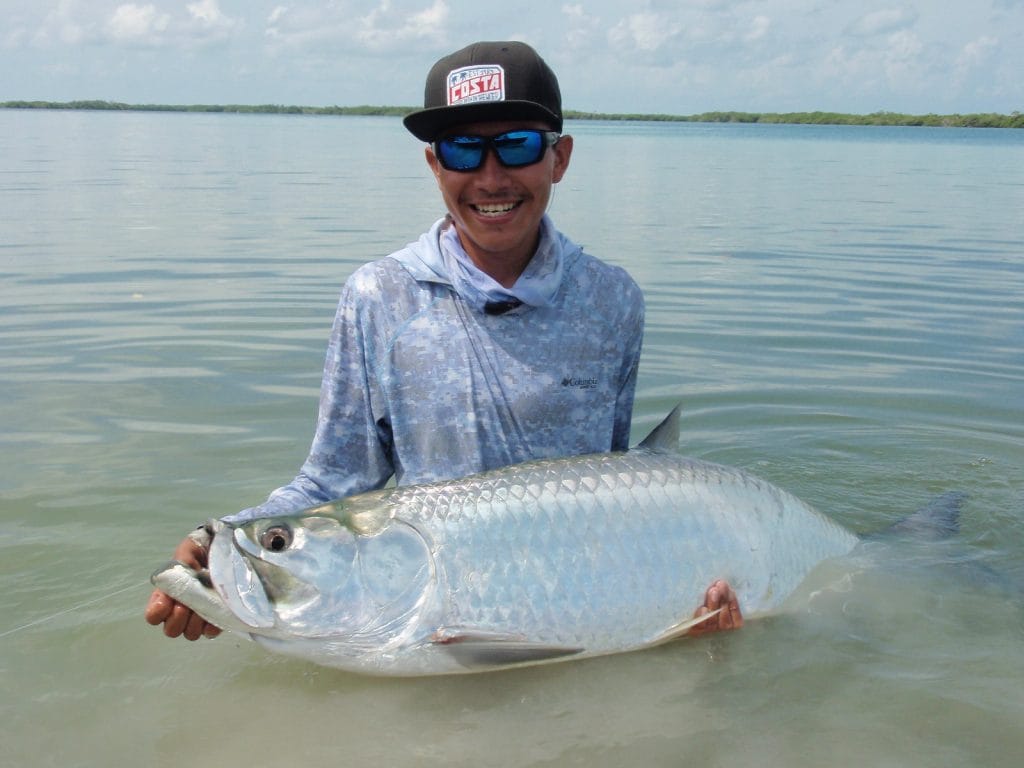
0,111,1024,766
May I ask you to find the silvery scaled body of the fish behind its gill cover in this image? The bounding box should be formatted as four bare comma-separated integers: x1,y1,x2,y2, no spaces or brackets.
392,452,856,652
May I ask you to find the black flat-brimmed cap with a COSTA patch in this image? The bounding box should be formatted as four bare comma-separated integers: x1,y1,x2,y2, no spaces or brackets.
403,42,562,141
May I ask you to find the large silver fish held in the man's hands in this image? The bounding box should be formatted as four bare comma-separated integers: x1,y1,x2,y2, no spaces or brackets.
153,409,872,675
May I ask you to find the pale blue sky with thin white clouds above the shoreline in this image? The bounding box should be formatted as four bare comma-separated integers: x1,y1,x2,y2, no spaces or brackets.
0,0,1024,115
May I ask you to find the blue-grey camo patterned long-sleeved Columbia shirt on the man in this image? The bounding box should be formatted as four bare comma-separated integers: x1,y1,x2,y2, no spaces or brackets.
227,217,644,520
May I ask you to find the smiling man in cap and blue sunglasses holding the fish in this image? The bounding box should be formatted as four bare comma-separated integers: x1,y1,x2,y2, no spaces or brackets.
145,42,742,640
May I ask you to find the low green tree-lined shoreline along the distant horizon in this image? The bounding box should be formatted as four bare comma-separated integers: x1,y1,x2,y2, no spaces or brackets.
0,100,1024,128
